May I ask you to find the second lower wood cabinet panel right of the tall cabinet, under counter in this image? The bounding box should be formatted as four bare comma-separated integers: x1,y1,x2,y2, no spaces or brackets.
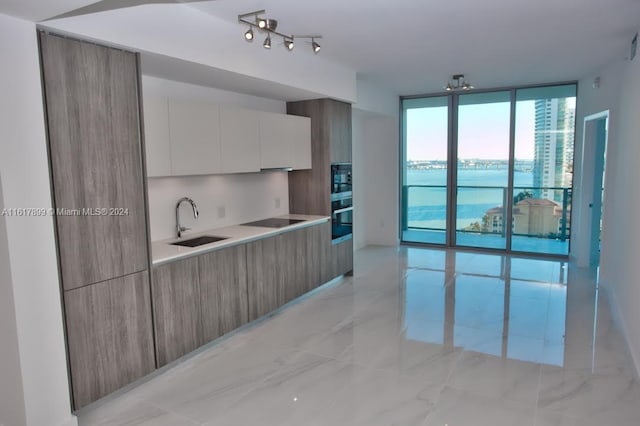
198,245,249,343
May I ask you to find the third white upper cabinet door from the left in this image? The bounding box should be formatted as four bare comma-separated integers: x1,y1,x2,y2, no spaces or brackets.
220,107,260,173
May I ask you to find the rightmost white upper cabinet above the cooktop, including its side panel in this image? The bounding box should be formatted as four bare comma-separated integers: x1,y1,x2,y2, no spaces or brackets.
260,112,311,169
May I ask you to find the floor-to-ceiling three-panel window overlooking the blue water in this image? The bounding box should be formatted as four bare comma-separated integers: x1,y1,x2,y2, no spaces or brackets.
401,84,576,255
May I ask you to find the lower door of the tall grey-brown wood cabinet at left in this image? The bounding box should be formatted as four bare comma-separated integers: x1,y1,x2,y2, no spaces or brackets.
64,271,155,408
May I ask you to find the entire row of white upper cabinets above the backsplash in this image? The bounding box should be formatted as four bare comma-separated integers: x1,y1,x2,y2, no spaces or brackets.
143,93,311,177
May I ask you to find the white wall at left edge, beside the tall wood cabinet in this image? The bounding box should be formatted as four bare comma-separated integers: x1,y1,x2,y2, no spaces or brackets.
0,15,76,426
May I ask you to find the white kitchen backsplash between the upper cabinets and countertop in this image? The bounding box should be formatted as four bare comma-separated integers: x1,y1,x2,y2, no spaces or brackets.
148,171,289,241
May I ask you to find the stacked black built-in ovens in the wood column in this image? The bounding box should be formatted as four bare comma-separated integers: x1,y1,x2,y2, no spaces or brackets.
331,163,353,244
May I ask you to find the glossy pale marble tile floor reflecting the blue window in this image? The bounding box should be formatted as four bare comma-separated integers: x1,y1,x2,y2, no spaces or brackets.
77,247,640,426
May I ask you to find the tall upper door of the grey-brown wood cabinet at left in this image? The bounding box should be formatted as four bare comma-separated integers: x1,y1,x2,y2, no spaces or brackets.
40,33,148,290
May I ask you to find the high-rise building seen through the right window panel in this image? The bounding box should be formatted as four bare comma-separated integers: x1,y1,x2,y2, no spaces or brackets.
533,98,576,202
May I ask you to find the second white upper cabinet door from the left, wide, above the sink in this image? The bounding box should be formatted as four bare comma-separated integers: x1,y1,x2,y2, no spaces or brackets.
169,99,222,176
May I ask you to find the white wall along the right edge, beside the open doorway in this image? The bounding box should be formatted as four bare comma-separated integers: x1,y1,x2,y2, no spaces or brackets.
578,52,640,370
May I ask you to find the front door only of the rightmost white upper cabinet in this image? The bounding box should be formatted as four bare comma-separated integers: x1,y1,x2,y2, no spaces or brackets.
260,112,292,169
